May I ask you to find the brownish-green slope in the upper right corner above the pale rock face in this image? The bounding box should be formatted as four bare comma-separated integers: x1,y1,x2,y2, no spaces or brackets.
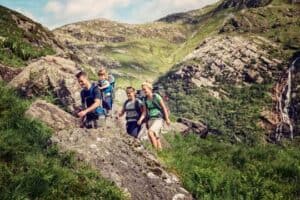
220,0,300,59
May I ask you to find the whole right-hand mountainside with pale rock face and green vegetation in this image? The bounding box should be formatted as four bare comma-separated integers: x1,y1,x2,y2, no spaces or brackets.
158,1,300,143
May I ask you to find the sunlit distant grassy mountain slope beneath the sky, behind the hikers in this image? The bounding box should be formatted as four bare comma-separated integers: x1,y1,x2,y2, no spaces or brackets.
54,1,222,86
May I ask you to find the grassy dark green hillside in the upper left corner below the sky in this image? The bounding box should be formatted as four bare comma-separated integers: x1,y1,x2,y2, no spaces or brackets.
0,6,55,67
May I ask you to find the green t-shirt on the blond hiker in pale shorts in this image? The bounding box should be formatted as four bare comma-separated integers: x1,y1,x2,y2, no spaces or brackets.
145,94,163,119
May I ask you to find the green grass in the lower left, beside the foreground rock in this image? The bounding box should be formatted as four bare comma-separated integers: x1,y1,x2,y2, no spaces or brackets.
0,84,124,199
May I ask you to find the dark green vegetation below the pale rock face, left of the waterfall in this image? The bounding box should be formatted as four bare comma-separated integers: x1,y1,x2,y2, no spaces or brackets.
160,72,272,145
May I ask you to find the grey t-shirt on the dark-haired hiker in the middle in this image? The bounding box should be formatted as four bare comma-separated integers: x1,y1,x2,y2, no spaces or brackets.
123,99,144,122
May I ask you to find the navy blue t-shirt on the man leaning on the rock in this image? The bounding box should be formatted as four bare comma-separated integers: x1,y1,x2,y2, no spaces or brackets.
80,85,101,108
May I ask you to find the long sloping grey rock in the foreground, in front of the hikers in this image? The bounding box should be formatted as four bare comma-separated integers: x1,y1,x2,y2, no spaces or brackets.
26,101,192,200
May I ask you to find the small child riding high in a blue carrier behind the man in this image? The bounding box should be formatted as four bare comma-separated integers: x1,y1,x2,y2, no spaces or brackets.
98,68,113,116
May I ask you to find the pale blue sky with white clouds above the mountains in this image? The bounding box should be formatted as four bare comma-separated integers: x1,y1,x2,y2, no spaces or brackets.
0,0,218,29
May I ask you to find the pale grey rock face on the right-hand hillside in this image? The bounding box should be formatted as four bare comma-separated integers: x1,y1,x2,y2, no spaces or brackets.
172,36,282,90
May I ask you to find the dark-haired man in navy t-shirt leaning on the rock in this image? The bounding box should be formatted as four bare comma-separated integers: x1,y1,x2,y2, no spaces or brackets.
76,71,105,128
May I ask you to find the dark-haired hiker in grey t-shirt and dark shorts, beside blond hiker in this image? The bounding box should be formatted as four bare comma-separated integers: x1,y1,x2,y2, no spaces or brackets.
119,87,146,138
